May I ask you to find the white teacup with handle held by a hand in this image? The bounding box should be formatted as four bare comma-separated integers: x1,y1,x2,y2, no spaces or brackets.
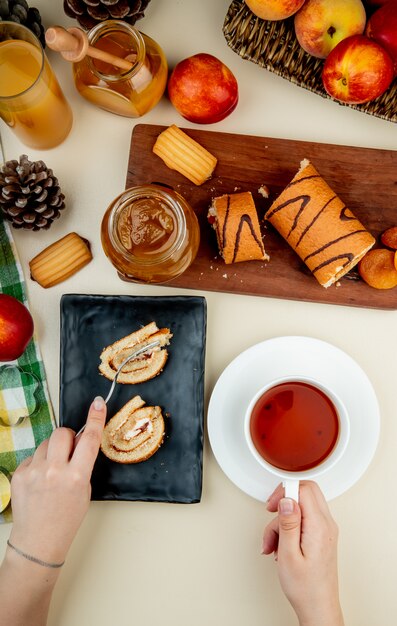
244,376,350,502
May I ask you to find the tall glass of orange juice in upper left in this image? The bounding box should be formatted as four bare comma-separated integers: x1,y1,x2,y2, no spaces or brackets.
0,22,73,150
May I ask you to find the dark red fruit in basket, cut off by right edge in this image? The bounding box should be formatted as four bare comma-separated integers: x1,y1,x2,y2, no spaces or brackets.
365,0,397,75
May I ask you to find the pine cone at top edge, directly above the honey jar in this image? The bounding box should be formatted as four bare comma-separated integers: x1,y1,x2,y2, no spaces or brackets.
63,0,149,30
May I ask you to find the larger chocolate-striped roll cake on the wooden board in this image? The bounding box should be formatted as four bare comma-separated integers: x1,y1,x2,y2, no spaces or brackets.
265,159,375,287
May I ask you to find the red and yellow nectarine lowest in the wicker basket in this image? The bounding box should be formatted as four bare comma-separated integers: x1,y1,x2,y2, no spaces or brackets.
322,35,393,104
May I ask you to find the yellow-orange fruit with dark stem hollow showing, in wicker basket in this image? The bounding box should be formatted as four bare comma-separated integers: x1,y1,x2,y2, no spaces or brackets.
294,0,366,59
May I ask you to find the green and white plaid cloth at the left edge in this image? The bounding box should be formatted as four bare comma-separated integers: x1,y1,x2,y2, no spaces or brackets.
0,219,55,523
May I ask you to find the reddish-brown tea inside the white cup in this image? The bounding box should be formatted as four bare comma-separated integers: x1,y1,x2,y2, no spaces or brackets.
249,381,340,472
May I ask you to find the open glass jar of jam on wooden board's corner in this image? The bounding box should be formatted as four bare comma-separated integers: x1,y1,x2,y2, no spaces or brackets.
101,185,200,283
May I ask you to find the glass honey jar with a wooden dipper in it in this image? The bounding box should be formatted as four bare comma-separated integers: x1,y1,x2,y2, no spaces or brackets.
73,20,168,117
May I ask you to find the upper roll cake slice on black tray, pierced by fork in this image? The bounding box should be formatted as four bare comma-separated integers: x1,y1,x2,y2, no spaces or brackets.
99,322,172,385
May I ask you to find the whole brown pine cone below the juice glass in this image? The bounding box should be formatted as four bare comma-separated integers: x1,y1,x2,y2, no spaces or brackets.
0,154,65,230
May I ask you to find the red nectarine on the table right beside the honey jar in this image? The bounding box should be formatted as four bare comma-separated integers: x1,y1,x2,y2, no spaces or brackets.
168,52,238,124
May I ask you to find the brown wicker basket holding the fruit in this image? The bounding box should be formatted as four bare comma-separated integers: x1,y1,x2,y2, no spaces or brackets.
223,0,397,122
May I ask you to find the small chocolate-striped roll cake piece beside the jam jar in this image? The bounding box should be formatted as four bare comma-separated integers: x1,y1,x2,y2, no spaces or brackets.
208,191,269,264
